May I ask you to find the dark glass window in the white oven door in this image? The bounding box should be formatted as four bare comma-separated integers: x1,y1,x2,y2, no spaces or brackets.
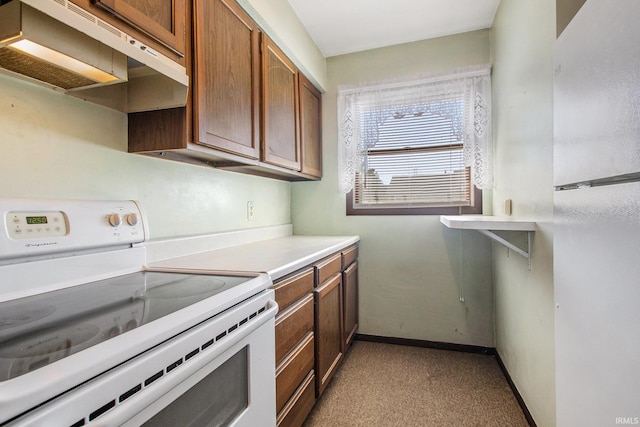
144,347,249,427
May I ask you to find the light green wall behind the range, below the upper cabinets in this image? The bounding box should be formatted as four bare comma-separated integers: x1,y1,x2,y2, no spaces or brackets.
0,75,290,238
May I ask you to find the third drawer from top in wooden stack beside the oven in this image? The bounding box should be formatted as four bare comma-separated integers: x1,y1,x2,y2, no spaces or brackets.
276,332,315,412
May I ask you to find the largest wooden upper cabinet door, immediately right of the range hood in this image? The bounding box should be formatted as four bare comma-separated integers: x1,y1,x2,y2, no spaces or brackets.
194,0,260,159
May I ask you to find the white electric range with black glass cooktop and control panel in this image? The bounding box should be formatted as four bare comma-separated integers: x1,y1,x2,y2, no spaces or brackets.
0,199,278,426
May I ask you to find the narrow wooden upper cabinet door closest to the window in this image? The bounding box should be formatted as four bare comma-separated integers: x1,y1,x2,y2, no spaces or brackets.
298,73,322,178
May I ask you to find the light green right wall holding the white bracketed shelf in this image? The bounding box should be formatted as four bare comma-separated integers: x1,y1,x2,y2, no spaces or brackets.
491,0,555,427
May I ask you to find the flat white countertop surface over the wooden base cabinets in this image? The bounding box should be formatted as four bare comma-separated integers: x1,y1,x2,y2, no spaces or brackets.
148,235,360,281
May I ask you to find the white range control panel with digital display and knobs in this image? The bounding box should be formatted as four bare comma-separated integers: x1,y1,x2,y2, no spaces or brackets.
0,199,148,259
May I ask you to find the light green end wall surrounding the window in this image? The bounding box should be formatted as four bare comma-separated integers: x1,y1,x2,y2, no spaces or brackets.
292,30,494,347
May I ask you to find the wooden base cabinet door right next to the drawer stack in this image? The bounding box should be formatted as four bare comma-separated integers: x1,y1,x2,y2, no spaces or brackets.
314,273,344,397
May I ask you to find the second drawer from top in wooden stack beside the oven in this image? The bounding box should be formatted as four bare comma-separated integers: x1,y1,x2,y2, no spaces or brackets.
276,294,314,366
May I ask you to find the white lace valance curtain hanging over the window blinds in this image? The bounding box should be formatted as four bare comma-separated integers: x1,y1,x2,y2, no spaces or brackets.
338,65,493,193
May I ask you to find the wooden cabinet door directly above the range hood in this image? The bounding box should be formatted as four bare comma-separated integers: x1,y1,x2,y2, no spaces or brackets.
92,0,187,57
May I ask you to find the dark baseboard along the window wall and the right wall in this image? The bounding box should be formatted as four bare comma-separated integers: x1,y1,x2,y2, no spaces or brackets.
354,334,537,427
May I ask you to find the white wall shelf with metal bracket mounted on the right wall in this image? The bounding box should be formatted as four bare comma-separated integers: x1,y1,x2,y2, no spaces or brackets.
440,215,536,269
